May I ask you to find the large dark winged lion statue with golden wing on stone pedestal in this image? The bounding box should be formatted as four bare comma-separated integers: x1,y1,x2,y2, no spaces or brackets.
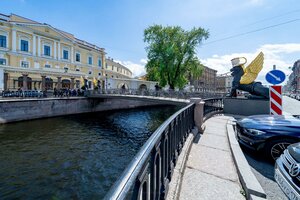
229,52,269,99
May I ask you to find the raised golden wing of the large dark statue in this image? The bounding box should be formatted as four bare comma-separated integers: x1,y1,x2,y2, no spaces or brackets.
240,52,264,84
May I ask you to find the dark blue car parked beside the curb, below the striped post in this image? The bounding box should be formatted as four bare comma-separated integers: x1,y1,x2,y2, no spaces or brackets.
236,115,300,160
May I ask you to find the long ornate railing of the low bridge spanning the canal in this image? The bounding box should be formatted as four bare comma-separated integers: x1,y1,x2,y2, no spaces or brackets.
89,89,226,99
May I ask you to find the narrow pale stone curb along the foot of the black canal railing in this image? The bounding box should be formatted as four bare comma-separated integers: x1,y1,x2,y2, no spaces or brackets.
166,127,199,200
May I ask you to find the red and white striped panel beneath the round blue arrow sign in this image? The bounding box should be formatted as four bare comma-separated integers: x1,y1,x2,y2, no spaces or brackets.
270,85,282,115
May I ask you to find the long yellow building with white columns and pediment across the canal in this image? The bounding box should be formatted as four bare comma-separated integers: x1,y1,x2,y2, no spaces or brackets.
0,14,132,91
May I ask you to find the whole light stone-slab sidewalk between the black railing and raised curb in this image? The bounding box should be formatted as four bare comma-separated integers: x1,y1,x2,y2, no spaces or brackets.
179,115,245,200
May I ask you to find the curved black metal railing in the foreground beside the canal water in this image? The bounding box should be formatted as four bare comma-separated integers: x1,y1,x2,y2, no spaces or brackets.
105,104,195,200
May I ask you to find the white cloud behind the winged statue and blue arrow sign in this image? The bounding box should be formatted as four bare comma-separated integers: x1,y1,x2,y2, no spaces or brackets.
200,43,300,84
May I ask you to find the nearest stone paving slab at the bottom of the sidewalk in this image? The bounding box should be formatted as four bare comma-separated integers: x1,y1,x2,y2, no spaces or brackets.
179,168,245,200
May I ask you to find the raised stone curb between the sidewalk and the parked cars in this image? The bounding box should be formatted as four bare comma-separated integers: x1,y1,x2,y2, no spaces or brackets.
227,118,267,200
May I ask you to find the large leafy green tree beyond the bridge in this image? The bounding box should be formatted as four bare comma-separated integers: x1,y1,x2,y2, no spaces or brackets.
144,25,209,89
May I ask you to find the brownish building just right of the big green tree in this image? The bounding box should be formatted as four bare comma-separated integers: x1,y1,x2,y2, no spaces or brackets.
190,66,217,92
